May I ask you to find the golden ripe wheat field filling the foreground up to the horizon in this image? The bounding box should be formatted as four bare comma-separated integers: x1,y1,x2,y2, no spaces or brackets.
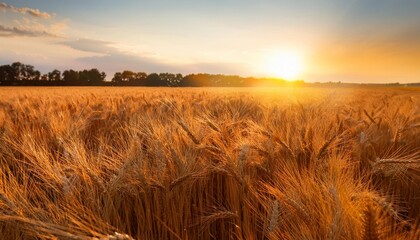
0,87,420,240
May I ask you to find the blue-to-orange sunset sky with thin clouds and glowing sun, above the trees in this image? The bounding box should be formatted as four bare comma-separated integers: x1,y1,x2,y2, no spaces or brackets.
0,0,420,83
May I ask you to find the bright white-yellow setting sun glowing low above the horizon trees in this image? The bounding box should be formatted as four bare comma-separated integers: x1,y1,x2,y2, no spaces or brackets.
266,52,303,81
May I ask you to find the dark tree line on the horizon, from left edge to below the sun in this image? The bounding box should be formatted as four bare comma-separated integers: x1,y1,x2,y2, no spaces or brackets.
0,62,303,87
